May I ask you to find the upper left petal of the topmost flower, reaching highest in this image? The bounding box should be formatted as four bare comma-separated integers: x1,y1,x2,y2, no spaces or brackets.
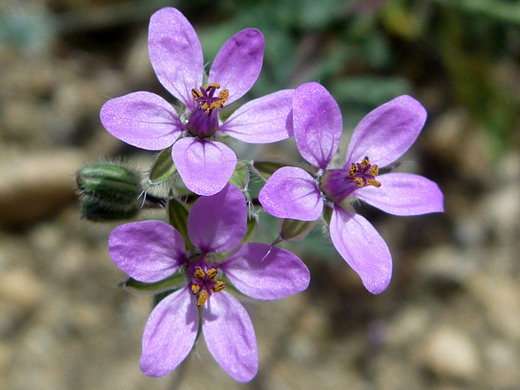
148,8,204,110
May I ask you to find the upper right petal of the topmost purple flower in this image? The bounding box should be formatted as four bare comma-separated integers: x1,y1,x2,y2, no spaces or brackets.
208,28,265,104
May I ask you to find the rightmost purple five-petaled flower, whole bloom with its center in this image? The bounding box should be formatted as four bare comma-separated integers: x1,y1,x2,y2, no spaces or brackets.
259,83,444,294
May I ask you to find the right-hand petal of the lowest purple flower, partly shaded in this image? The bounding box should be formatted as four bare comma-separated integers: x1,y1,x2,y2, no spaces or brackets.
221,243,310,300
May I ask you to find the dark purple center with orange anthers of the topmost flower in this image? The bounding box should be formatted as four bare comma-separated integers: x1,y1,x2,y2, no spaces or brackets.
186,83,229,138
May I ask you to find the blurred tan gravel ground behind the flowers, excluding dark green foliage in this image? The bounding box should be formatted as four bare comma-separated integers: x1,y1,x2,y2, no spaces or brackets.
0,1,520,390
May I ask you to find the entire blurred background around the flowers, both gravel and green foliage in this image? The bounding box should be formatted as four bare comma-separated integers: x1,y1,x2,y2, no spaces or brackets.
0,0,520,390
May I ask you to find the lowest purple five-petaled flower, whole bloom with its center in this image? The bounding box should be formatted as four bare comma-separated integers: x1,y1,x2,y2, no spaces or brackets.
109,185,310,382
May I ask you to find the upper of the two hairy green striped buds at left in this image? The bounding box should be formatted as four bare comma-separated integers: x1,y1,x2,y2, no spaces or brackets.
76,163,143,206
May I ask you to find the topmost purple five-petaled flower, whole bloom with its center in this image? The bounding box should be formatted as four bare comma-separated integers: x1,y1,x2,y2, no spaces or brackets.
101,8,294,196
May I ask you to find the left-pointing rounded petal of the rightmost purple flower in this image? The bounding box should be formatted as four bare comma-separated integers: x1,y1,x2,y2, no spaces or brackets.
258,167,323,221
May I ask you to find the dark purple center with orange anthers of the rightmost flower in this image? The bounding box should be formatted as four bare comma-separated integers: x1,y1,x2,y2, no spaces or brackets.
320,156,381,202
